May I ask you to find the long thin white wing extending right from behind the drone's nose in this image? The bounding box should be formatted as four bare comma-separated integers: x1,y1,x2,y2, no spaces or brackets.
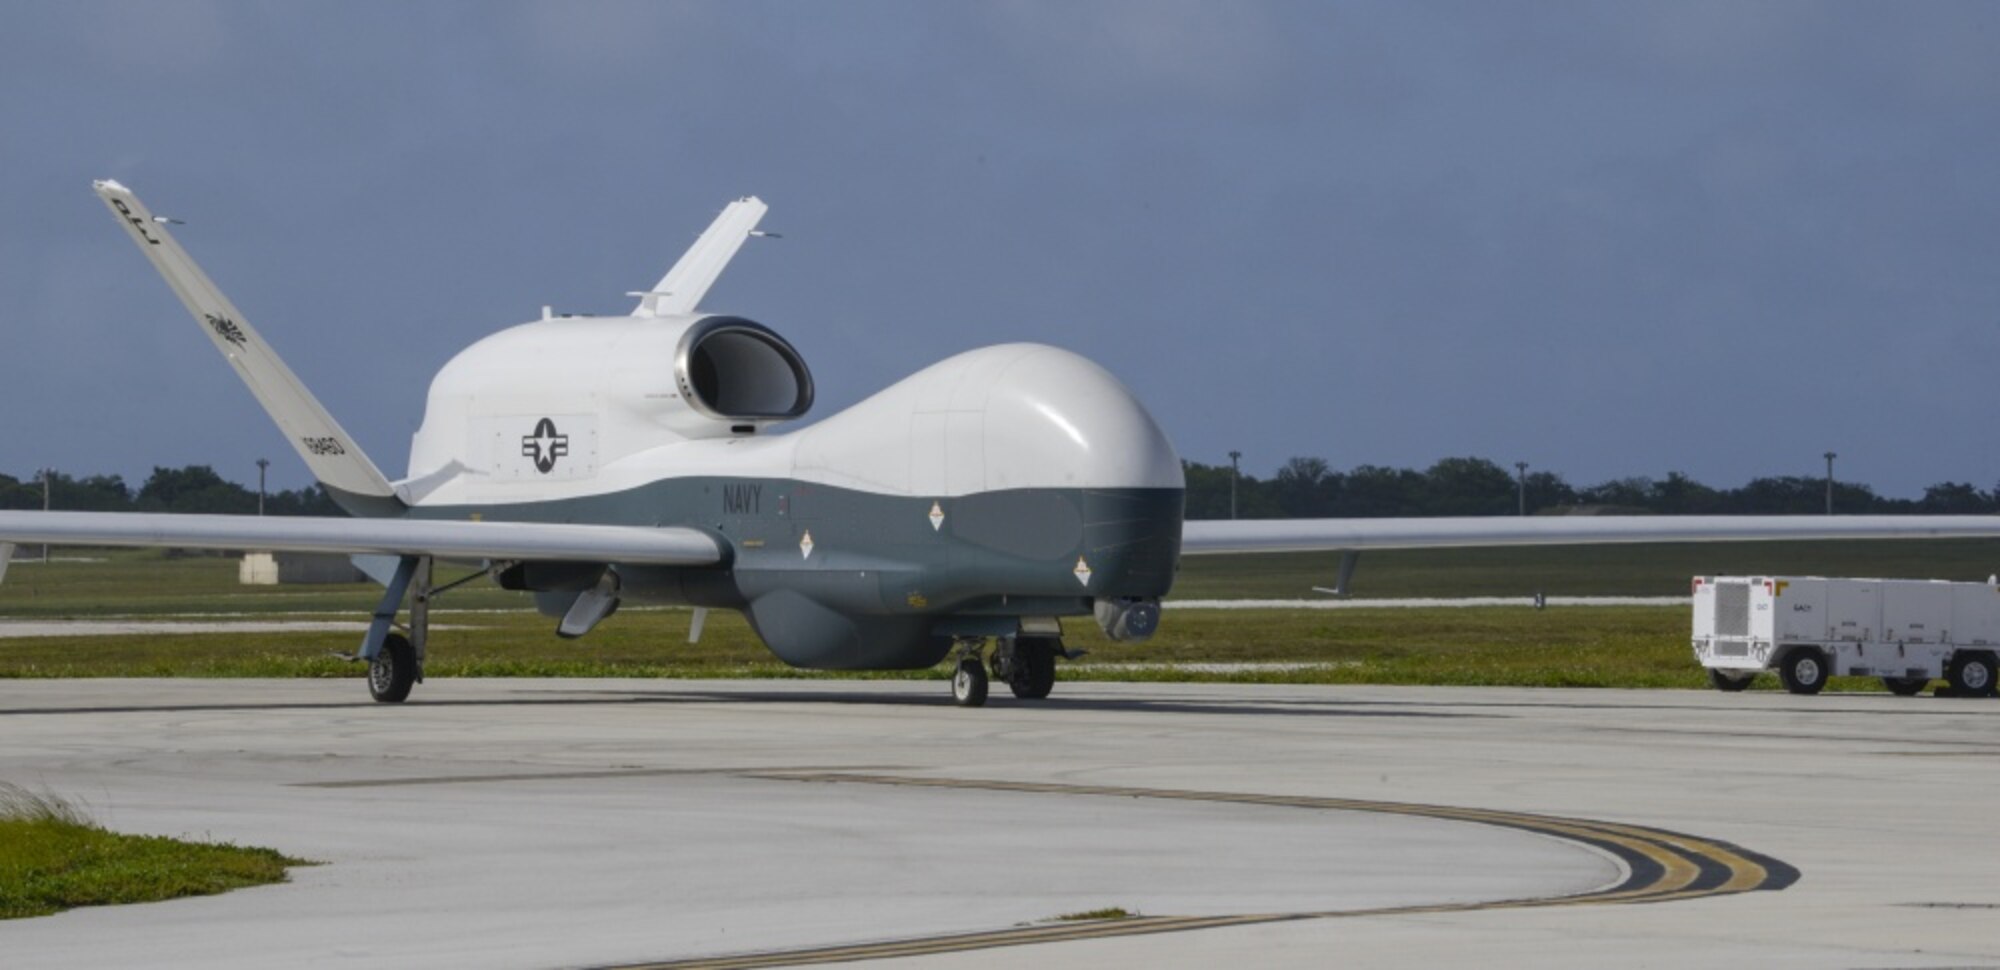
1180,516,2000,556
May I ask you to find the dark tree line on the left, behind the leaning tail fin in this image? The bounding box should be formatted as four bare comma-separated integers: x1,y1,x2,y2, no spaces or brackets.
0,464,344,516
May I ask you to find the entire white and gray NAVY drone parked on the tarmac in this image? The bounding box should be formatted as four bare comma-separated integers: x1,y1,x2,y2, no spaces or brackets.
0,180,2000,706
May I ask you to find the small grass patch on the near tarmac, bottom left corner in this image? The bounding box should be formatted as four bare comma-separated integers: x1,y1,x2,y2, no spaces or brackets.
0,782,308,920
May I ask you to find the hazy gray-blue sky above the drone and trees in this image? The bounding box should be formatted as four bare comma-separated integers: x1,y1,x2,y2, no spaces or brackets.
0,0,2000,496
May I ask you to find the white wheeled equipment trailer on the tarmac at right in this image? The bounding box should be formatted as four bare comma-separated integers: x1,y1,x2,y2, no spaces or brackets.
1694,576,2000,696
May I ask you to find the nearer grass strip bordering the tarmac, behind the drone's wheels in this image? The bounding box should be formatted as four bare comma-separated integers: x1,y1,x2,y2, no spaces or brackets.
0,606,1882,692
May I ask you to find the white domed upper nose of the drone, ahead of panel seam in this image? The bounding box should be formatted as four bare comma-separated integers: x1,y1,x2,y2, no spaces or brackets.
982,346,1184,488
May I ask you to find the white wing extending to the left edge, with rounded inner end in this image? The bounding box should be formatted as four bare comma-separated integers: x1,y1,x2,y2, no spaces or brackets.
0,512,724,566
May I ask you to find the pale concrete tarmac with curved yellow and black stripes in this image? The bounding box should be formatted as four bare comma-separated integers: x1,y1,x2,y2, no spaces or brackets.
0,680,2000,968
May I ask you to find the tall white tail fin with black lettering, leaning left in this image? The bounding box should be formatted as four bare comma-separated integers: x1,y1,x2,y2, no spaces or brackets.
96,180,402,514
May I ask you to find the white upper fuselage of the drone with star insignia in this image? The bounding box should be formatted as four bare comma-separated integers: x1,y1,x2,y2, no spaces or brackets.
398,316,1182,506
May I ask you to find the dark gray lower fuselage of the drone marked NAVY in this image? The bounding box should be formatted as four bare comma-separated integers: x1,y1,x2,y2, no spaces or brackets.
408,476,1184,670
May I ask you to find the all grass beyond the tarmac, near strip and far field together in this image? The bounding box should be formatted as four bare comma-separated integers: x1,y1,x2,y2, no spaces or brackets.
0,540,2000,690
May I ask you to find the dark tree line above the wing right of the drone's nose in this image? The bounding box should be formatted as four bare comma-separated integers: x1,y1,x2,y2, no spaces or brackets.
1182,458,2000,518
